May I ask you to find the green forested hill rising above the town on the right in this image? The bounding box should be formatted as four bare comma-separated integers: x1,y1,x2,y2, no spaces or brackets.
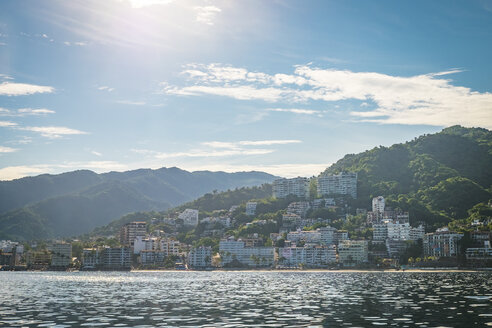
322,126,492,225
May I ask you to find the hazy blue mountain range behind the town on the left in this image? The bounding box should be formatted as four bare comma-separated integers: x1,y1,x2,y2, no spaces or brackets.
0,167,275,240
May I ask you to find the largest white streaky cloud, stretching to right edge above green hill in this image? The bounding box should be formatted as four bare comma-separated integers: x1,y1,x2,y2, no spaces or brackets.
164,64,492,129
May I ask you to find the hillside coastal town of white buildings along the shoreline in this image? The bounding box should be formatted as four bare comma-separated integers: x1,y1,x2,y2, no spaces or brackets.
0,172,492,270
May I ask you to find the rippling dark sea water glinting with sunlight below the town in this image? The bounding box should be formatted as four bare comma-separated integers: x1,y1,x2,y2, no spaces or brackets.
0,272,492,327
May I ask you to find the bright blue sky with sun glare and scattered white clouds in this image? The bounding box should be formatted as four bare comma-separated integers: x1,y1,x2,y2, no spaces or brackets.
0,0,492,180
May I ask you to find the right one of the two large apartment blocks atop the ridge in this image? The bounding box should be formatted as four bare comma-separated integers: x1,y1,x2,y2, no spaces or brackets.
318,172,357,199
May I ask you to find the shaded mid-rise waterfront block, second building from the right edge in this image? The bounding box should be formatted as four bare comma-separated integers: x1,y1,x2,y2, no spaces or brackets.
423,228,463,257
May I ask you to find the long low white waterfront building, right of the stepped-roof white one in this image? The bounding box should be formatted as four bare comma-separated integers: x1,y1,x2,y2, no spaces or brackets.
279,245,337,268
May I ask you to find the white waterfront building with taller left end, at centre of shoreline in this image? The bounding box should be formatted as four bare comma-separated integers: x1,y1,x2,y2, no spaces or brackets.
219,239,275,267
